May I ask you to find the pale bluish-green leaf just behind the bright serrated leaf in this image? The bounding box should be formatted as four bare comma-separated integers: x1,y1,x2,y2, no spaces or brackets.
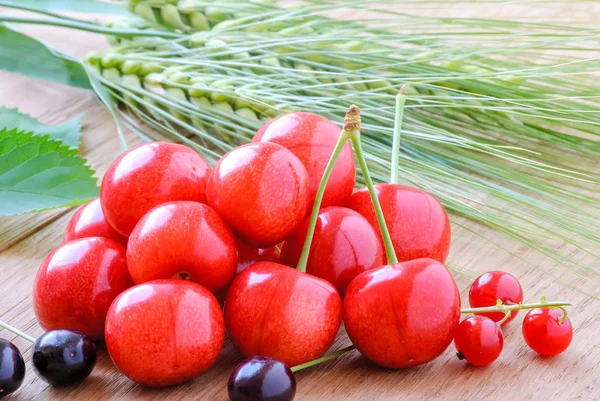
0,106,84,148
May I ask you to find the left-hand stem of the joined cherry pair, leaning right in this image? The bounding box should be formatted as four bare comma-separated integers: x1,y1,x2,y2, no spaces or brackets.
296,106,356,273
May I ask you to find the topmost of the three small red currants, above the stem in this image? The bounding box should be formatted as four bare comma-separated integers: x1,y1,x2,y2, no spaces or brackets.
469,271,523,324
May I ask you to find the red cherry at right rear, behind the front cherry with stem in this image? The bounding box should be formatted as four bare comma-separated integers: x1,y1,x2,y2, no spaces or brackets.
347,184,450,263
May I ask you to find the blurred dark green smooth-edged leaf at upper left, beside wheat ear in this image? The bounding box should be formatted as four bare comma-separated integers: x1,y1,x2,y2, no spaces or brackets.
0,24,91,89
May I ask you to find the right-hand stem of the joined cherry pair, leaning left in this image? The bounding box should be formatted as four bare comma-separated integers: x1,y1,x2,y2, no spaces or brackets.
348,106,398,264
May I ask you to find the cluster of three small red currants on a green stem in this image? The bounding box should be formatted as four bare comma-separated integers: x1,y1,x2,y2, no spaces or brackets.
454,271,573,366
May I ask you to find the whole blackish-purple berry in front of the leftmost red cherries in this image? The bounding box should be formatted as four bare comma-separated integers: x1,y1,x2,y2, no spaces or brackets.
31,329,97,386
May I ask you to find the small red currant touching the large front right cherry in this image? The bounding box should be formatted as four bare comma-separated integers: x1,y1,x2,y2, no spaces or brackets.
454,316,504,366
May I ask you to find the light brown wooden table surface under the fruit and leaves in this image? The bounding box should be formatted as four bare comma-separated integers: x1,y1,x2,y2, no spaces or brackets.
0,3,600,401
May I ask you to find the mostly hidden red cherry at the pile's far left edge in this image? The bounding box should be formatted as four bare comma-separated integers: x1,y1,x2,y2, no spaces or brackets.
64,198,127,246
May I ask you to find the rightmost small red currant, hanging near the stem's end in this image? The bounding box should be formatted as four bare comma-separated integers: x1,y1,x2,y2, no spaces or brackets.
523,308,573,356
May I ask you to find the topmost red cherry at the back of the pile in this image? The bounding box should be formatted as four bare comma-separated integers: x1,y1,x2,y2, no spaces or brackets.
252,112,356,207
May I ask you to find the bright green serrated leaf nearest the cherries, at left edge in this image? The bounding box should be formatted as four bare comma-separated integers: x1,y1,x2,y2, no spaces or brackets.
0,129,98,216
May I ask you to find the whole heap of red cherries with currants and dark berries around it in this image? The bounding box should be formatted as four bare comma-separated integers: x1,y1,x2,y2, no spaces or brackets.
0,109,572,400
